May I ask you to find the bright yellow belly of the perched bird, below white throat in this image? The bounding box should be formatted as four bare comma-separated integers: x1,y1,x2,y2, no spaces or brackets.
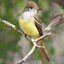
19,18,39,37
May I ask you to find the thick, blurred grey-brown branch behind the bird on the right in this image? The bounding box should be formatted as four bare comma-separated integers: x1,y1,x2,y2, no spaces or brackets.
44,14,64,32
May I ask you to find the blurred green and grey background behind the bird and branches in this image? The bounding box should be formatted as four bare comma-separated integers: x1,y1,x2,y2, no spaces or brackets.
0,0,64,64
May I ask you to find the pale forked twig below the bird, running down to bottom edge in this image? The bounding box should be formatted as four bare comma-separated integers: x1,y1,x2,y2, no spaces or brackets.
17,33,51,64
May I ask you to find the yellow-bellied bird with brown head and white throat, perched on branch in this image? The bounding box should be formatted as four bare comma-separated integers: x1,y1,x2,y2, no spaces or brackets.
19,1,49,61
